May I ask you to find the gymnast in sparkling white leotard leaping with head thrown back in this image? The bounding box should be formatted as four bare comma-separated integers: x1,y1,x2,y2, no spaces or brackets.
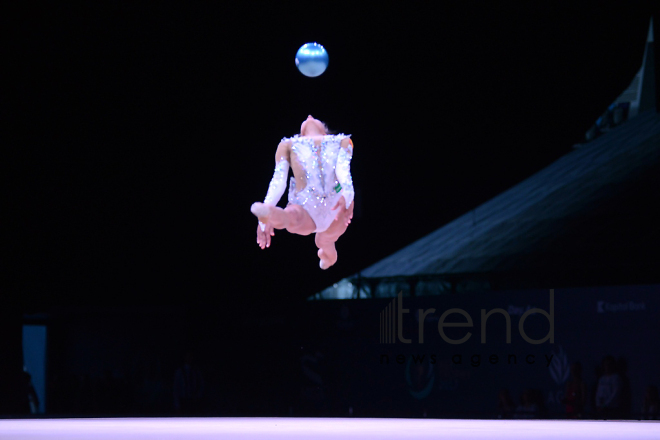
251,115,355,269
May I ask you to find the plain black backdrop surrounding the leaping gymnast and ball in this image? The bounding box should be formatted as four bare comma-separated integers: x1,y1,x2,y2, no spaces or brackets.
2,2,658,418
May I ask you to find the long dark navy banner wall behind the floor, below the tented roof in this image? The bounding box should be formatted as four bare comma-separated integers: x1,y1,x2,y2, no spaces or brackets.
38,285,660,419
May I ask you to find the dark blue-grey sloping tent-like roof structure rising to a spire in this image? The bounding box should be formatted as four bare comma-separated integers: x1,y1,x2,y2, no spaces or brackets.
309,17,660,300
